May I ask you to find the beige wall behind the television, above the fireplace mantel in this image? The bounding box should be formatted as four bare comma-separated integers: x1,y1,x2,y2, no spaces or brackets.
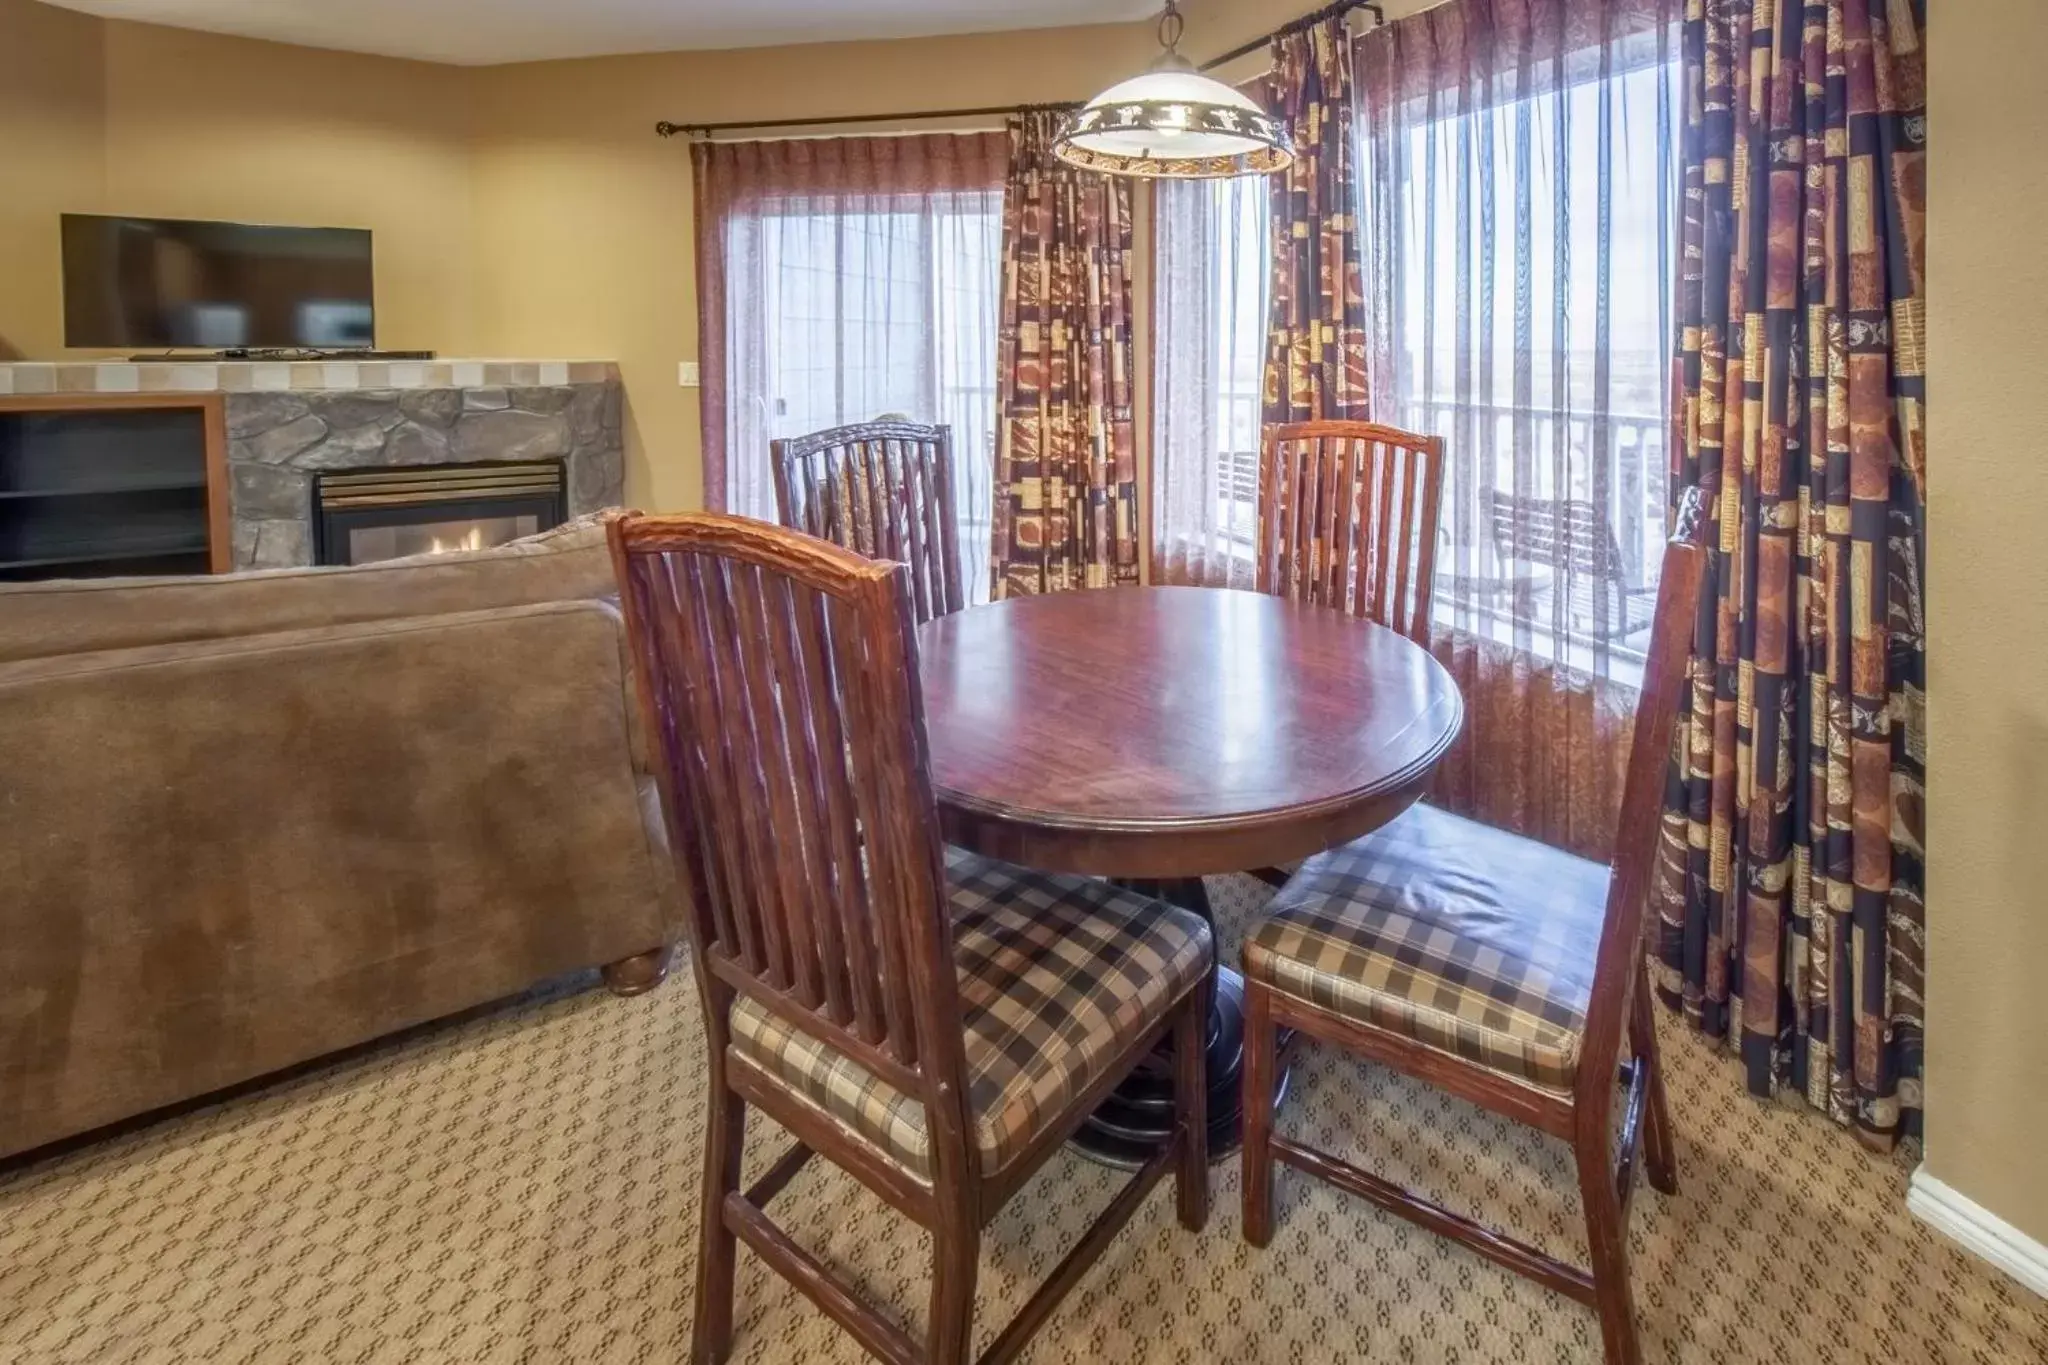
0,0,481,358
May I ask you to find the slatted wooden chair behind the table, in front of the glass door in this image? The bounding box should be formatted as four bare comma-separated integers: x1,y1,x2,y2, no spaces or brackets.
770,420,967,624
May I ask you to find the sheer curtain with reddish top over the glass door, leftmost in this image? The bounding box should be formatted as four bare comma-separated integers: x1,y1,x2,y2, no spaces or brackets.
698,133,1008,602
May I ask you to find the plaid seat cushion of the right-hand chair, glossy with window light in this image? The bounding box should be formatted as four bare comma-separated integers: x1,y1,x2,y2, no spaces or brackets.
1245,806,1608,1091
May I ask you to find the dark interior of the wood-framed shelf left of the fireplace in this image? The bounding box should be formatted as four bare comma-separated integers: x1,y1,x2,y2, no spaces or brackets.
0,407,209,581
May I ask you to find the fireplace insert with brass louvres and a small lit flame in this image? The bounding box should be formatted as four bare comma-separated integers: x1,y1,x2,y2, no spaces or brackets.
305,460,563,565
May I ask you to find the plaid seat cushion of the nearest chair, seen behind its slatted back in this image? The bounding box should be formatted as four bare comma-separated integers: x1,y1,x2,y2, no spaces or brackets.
729,849,1210,1179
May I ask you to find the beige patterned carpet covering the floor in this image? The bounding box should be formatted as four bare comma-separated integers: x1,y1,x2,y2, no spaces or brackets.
0,878,2048,1365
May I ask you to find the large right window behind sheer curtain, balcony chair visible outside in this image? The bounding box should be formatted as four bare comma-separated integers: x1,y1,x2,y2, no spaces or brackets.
1362,46,1677,681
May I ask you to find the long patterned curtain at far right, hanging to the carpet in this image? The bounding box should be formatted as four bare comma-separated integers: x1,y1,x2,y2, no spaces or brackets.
1659,0,1927,1146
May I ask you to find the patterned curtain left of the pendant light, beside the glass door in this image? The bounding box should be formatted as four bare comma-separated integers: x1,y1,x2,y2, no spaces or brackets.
991,111,1139,598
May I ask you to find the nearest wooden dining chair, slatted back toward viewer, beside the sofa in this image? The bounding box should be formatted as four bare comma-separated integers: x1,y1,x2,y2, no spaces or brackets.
610,516,1212,1365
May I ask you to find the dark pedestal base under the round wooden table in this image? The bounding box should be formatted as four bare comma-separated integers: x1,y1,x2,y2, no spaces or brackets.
1073,878,1288,1169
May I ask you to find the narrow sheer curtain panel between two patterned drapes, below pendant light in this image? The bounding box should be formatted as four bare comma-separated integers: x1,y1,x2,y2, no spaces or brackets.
1153,176,1270,587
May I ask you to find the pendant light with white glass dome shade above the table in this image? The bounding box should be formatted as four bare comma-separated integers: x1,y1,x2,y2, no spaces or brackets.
1053,0,1294,180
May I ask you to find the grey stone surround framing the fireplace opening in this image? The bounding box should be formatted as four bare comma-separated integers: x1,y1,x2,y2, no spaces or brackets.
225,379,625,569
